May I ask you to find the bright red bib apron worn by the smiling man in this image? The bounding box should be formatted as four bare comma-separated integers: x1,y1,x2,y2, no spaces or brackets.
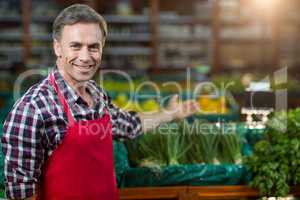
38,74,119,200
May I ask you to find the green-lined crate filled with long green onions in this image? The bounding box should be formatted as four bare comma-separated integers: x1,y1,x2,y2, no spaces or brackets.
114,120,248,187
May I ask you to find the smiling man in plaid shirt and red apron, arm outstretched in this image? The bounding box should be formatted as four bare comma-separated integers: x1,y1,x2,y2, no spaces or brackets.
2,4,197,200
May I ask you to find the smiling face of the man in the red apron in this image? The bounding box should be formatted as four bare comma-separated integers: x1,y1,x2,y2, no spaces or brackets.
54,23,103,83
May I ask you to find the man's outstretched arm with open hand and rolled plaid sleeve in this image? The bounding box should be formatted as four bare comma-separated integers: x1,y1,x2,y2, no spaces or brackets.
106,88,198,139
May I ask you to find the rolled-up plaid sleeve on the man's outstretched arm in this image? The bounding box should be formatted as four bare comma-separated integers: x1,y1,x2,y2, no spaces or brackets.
107,97,142,139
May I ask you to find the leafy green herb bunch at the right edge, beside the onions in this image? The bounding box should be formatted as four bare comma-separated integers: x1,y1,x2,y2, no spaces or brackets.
244,109,300,196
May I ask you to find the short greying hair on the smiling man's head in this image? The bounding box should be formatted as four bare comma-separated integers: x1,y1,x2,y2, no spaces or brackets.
52,4,107,44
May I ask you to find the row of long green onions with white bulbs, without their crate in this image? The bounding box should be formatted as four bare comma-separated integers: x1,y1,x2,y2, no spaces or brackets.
126,120,241,167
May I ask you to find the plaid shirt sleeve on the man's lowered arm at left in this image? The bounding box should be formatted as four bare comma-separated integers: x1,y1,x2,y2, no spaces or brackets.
1,102,44,199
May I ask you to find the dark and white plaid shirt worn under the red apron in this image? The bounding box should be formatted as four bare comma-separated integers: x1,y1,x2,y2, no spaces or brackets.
2,69,142,199
